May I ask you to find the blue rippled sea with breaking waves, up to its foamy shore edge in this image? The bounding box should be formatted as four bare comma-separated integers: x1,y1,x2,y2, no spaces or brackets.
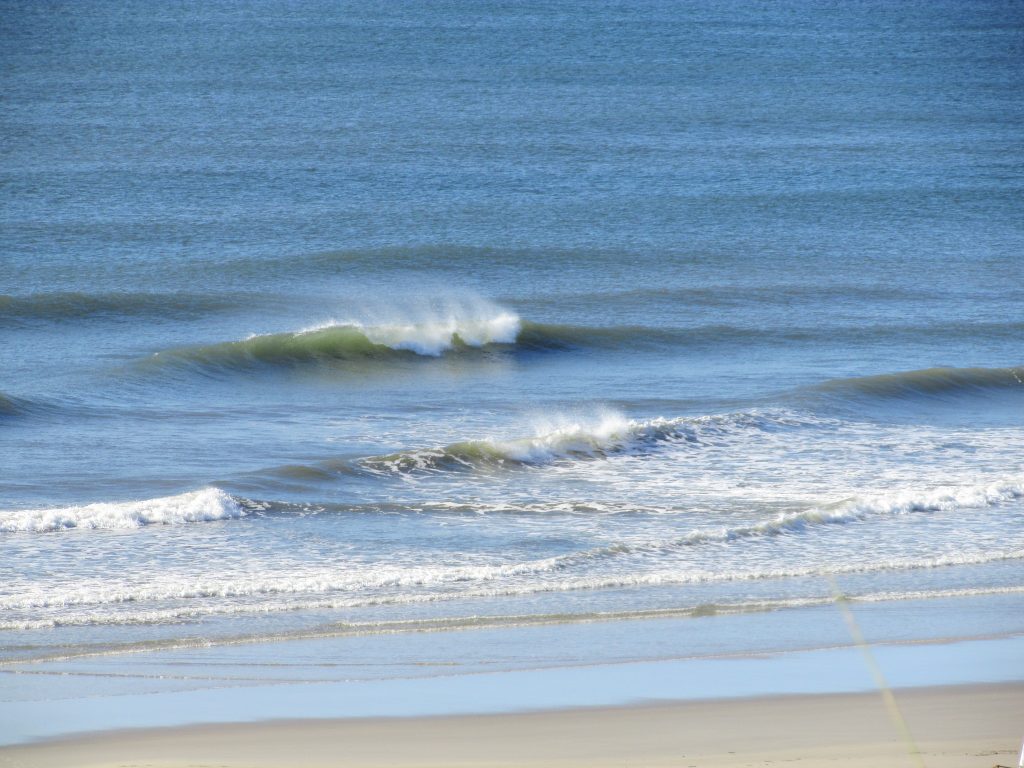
0,0,1024,729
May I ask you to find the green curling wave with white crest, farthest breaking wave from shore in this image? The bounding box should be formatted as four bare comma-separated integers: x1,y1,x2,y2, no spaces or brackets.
154,302,521,368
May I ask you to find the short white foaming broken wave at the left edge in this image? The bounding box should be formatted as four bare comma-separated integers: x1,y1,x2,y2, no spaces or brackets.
0,488,247,534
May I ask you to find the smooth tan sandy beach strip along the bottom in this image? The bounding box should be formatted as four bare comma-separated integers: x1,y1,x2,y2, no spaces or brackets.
0,683,1024,768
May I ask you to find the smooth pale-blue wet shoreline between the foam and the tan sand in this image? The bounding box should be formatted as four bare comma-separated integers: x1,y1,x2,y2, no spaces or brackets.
0,596,1024,749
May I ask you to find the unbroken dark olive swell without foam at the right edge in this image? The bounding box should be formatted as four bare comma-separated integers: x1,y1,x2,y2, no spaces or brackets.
810,367,1024,398
